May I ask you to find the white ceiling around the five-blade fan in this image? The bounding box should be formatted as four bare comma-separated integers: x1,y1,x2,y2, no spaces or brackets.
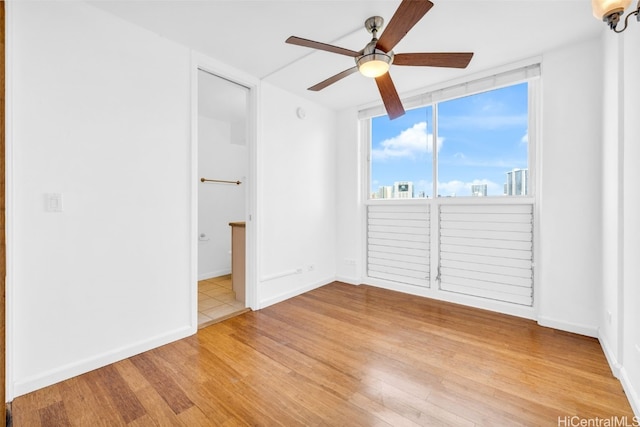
90,0,605,113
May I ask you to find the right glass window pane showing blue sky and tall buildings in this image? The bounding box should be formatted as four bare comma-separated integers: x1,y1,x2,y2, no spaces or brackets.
437,83,529,197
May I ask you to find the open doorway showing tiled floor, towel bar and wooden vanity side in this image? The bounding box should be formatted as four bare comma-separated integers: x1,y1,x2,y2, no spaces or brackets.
197,69,250,327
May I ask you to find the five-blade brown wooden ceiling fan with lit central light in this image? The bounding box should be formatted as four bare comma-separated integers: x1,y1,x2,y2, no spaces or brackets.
286,0,473,119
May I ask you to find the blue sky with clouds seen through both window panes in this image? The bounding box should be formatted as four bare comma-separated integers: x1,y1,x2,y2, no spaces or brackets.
371,83,528,197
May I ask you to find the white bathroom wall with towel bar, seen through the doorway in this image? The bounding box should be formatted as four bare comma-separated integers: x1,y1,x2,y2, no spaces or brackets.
198,114,249,280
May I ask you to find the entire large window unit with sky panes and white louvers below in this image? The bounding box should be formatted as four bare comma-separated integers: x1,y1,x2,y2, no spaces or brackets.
359,64,540,312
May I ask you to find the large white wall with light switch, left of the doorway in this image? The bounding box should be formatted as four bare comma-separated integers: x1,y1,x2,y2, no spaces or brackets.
7,2,196,399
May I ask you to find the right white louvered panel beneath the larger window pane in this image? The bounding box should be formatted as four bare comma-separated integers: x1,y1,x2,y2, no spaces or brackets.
439,204,533,306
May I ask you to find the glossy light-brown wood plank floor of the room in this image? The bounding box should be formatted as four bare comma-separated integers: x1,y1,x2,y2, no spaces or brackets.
13,282,633,427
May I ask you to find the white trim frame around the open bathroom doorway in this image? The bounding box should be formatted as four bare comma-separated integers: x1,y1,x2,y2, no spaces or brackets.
189,52,260,333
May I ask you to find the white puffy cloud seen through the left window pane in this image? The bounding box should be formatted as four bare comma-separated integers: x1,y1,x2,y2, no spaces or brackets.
371,122,443,160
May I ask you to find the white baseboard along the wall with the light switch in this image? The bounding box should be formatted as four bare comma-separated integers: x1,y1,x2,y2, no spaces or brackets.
11,326,197,398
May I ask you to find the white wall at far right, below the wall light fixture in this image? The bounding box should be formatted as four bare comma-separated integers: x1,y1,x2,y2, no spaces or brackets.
599,21,640,414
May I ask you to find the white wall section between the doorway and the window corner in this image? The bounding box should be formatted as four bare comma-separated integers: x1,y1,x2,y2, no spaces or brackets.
257,83,337,307
